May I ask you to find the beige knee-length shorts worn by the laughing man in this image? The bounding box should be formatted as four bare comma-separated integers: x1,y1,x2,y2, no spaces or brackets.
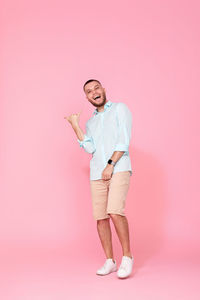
90,171,131,220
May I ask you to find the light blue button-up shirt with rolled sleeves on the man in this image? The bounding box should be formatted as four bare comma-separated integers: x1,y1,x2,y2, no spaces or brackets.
77,101,132,180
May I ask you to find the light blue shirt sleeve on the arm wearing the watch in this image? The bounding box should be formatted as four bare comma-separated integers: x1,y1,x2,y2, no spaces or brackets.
114,102,132,152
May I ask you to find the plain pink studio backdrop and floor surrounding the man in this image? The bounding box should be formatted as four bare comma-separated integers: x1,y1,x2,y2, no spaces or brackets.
0,0,200,300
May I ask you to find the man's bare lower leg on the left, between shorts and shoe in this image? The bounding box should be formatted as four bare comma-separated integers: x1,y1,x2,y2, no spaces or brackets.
97,218,114,262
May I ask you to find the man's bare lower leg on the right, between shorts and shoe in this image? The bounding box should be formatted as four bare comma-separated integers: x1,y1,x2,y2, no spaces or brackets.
110,214,132,257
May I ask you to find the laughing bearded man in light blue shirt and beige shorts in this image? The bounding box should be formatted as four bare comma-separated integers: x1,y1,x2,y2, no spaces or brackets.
66,79,134,278
